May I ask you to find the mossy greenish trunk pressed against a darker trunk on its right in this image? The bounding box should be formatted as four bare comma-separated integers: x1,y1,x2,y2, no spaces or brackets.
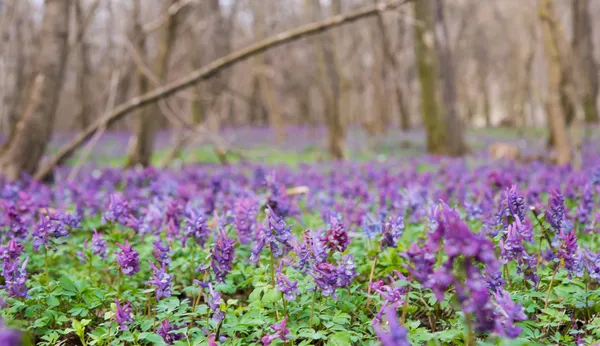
413,1,445,154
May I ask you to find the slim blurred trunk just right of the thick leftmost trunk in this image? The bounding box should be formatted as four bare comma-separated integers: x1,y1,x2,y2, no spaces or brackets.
75,0,92,129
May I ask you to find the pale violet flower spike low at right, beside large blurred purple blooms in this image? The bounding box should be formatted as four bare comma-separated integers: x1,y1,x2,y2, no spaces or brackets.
493,291,527,339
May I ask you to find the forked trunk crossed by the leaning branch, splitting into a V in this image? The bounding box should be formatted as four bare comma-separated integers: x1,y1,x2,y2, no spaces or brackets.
127,0,178,167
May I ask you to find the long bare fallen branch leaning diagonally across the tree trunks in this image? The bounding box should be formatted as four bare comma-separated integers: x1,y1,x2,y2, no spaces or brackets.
34,0,411,180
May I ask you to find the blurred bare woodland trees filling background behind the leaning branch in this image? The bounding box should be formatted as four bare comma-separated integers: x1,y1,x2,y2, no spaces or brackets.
0,0,600,175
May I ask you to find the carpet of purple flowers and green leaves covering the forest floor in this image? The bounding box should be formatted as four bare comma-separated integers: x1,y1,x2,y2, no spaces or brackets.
0,132,600,346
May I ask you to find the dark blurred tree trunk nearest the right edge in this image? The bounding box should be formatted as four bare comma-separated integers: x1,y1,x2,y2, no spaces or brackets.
572,0,599,123
